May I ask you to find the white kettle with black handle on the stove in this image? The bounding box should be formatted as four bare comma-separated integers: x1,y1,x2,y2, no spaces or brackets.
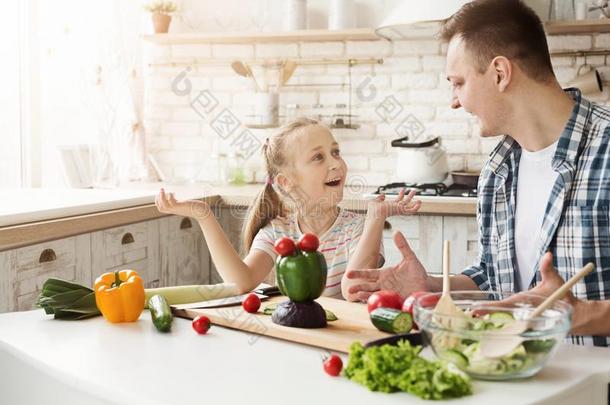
391,136,449,184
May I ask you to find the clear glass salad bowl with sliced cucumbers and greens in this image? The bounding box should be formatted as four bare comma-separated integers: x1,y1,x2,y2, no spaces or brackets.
414,291,572,381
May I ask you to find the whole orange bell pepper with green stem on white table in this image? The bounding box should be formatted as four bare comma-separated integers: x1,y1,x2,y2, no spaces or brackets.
93,270,145,323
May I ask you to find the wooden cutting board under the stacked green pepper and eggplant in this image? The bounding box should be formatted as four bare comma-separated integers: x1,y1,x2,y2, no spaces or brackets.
174,296,390,353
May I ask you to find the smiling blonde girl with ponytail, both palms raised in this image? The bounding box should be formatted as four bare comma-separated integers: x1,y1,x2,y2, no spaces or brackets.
156,118,421,298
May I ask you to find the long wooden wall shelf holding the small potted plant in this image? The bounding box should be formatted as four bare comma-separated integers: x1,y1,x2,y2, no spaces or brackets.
143,28,381,45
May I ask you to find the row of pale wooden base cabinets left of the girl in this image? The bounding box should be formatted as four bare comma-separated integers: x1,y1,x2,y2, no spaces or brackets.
0,216,214,312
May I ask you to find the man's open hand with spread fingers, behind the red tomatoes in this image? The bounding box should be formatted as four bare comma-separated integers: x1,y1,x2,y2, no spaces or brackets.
346,232,429,301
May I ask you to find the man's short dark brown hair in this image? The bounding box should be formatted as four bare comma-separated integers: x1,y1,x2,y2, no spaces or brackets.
440,0,555,82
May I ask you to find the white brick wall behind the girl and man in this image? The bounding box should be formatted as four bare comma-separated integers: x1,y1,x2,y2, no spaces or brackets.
144,34,610,186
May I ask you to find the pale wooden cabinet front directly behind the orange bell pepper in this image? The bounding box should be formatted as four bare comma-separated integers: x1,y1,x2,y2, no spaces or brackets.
91,220,161,288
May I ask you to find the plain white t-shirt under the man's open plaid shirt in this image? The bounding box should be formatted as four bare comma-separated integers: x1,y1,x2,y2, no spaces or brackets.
515,142,558,291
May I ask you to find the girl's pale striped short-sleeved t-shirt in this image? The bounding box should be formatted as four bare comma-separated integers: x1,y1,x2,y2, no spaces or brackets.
252,210,383,298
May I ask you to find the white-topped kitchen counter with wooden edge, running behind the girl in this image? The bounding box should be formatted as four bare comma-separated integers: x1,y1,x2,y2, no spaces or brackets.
0,183,476,251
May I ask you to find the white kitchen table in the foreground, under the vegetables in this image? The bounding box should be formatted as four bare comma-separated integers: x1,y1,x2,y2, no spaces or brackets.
0,310,610,405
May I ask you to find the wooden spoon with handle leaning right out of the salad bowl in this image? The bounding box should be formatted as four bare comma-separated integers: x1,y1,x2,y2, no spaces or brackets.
480,263,595,358
